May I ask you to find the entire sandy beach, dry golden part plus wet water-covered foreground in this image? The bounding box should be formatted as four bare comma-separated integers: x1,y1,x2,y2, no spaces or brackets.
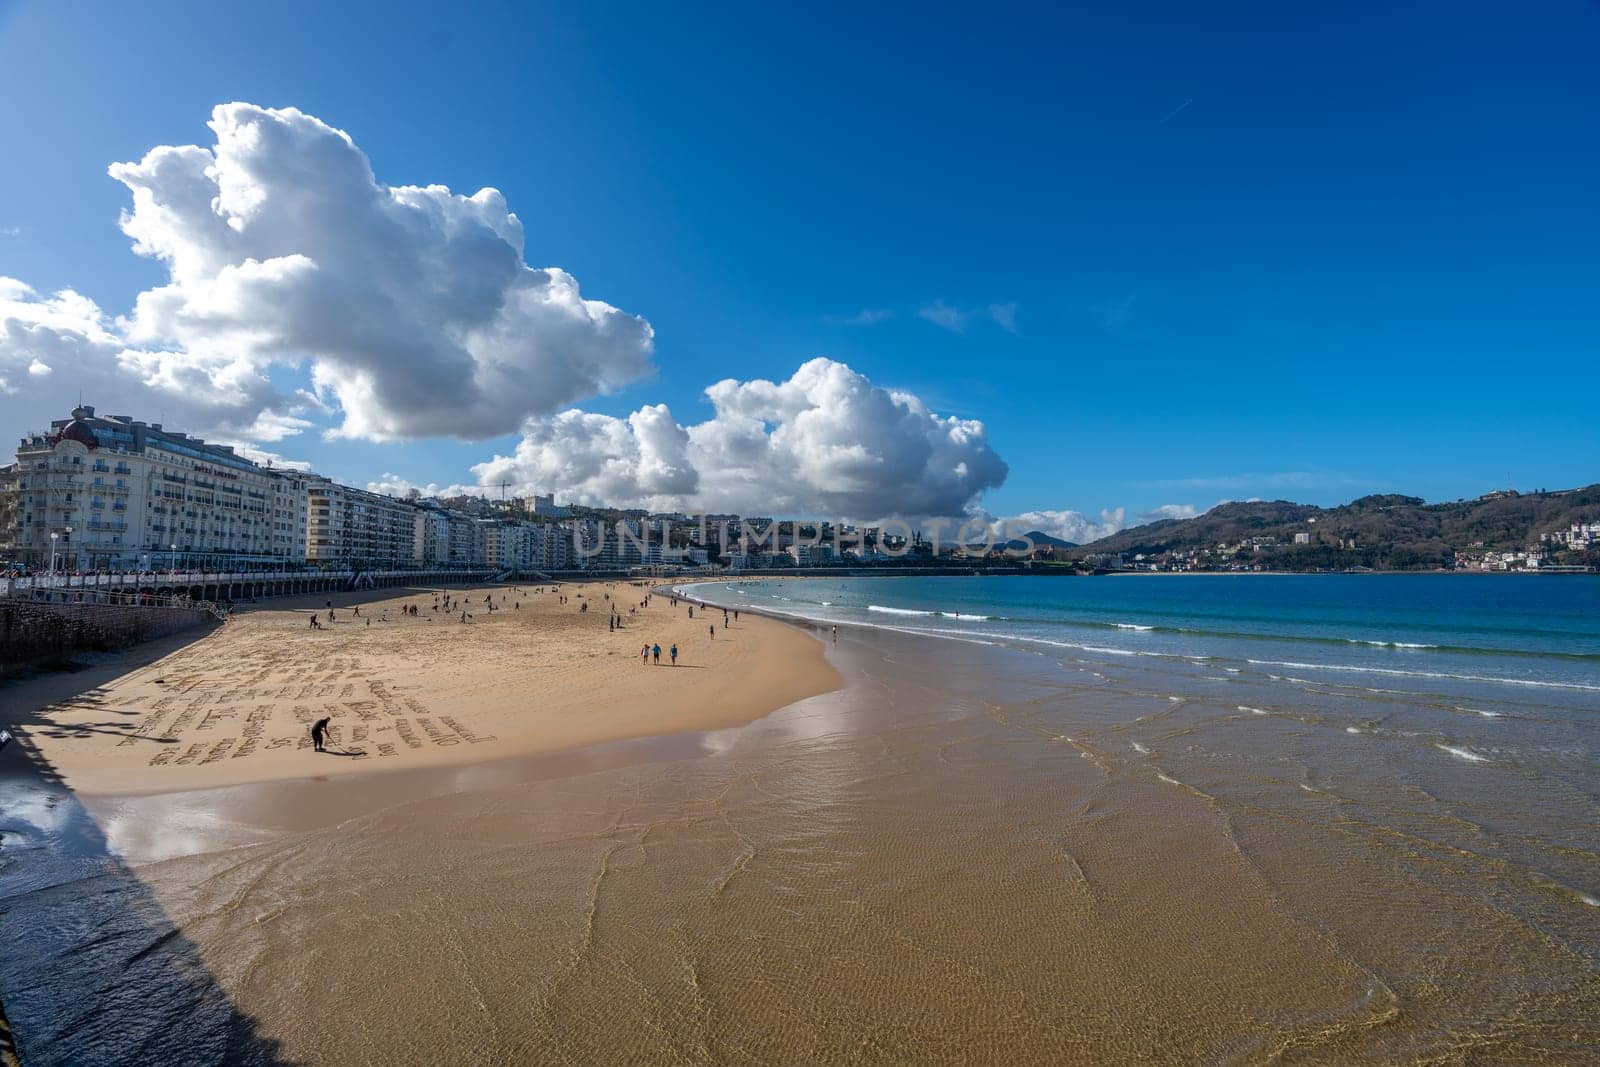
0,585,1600,1064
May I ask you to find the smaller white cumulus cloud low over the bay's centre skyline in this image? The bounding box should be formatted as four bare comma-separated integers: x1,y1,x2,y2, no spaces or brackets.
472,358,1006,520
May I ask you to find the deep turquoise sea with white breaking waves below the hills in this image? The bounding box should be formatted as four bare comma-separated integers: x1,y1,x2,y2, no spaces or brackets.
684,574,1600,702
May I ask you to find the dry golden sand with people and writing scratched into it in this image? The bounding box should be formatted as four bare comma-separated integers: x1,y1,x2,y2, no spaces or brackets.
6,582,838,795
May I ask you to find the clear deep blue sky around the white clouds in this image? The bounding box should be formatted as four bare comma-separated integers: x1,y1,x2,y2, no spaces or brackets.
0,0,1600,531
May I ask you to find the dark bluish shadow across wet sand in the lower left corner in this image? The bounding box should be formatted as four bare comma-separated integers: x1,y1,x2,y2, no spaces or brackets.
0,638,290,1067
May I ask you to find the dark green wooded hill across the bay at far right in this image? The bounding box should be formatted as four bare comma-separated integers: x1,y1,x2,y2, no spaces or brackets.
1075,485,1600,569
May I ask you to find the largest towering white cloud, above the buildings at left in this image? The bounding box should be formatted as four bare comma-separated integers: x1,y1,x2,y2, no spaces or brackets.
0,104,653,440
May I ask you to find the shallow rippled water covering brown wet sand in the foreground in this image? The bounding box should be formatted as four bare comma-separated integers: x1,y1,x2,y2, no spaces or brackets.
0,584,1600,1064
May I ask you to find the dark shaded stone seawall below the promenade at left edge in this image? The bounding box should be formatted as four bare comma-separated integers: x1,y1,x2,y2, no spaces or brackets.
0,600,216,675
